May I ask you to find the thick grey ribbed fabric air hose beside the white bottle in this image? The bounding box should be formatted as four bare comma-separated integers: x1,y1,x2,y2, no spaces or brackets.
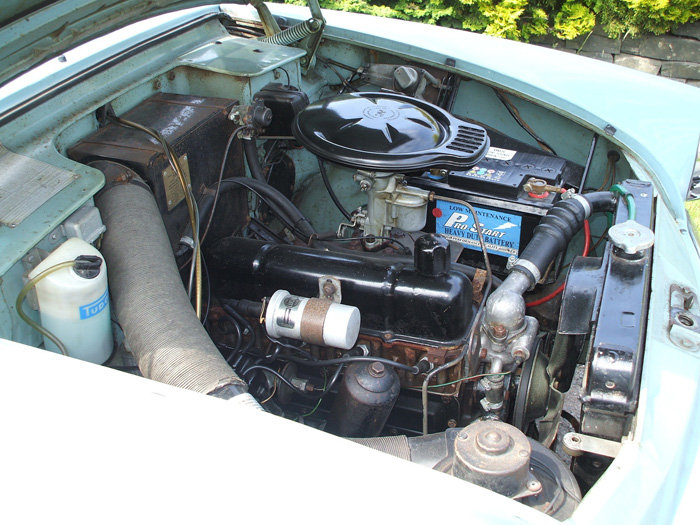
91,161,260,408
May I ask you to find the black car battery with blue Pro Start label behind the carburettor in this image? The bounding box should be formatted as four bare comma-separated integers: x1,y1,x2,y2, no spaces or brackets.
407,141,583,276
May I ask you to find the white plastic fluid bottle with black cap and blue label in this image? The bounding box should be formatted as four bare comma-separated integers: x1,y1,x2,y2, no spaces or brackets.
29,237,112,364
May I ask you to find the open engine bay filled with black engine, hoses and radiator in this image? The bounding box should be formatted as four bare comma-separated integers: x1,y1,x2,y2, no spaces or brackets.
0,11,654,520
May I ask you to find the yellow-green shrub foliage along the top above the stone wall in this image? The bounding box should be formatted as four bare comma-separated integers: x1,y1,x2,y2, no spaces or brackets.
277,0,700,41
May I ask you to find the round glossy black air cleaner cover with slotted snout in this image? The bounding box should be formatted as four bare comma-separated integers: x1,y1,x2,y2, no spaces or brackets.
292,93,489,171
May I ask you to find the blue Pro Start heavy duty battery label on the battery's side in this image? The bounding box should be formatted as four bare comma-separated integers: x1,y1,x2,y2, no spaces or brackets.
433,200,522,257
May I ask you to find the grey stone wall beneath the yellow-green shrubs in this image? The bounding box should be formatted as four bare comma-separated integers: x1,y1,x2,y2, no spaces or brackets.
532,22,700,87
